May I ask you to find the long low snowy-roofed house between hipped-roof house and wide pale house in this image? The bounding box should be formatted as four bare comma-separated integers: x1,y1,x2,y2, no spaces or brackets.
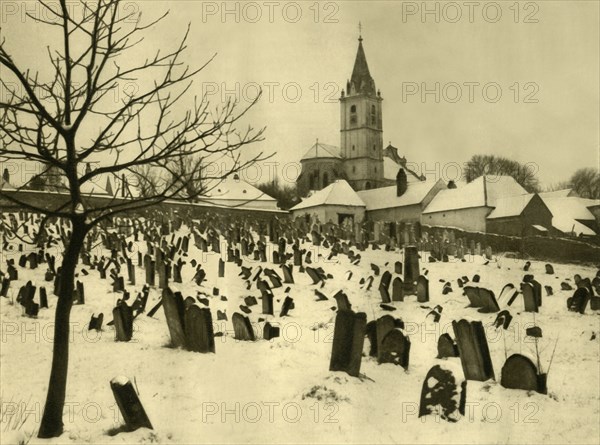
358,167,446,222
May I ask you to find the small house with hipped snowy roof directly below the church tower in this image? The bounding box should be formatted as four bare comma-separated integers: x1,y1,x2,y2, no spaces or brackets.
290,179,366,224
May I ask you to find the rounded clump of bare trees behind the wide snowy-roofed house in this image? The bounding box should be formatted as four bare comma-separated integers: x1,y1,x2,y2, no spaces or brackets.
465,155,540,193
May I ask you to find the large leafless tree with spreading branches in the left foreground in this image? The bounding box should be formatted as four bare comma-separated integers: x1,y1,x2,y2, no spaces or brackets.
0,0,265,438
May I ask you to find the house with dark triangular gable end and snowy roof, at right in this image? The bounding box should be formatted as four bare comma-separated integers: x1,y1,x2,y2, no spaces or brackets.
486,193,553,236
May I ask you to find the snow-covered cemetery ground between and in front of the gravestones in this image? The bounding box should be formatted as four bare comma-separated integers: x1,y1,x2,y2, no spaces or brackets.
0,229,600,444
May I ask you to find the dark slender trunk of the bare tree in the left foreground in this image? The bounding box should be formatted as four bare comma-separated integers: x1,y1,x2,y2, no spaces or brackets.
38,217,87,438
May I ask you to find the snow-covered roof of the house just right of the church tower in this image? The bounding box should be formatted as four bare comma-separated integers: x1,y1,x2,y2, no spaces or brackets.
358,179,444,210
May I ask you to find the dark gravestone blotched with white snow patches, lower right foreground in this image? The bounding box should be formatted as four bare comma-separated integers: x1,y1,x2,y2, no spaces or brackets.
419,365,467,422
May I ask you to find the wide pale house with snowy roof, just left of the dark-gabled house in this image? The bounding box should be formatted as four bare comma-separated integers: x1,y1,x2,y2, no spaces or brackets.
421,176,527,232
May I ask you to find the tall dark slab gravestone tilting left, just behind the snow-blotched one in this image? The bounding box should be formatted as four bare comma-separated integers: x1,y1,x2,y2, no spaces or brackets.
452,320,494,382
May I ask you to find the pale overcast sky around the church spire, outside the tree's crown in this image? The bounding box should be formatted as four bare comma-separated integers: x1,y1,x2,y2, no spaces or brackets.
1,1,600,185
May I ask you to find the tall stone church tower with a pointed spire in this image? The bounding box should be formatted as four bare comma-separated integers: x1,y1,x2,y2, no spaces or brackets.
340,30,385,190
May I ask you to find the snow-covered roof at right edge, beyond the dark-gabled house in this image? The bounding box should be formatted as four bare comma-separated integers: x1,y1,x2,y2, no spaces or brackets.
542,196,596,235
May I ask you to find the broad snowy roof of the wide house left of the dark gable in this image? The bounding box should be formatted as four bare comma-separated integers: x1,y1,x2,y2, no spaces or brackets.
423,176,527,214
